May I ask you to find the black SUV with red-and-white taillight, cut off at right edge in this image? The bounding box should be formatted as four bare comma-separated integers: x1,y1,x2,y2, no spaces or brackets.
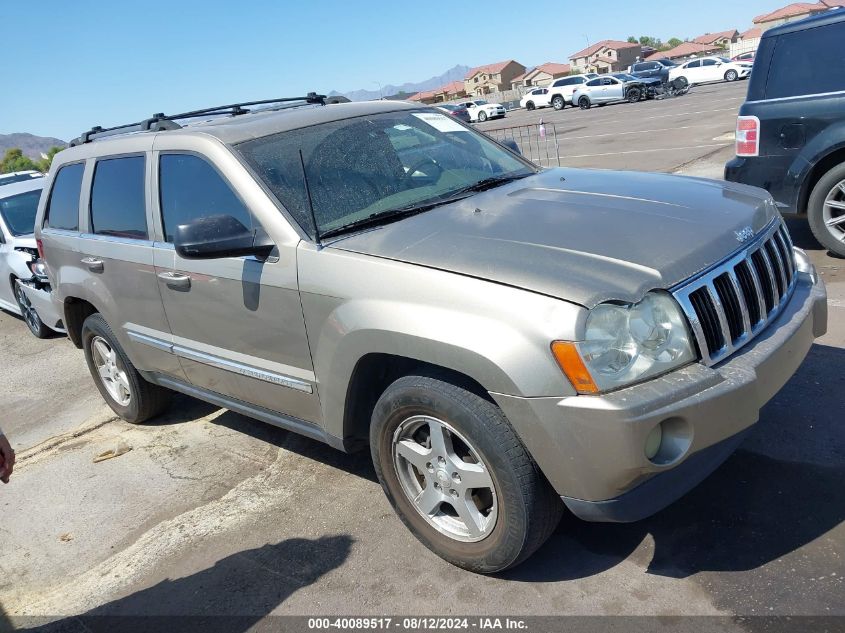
725,9,845,257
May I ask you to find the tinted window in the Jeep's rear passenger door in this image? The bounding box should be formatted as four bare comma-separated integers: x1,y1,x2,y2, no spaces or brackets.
91,156,148,240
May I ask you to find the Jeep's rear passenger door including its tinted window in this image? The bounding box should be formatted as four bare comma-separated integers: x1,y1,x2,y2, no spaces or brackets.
77,149,184,377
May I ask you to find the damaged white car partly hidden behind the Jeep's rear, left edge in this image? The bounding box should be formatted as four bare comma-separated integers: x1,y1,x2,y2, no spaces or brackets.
0,172,64,338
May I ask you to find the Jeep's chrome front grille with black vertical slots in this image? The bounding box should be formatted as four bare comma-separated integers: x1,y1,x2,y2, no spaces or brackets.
672,220,796,365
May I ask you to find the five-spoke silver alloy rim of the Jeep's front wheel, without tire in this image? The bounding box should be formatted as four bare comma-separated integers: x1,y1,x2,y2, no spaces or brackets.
393,415,498,542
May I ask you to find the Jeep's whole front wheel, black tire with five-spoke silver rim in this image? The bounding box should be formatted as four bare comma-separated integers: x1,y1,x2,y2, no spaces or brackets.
370,376,563,574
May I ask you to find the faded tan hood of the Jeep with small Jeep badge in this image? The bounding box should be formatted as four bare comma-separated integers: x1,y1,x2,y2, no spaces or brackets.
330,169,777,307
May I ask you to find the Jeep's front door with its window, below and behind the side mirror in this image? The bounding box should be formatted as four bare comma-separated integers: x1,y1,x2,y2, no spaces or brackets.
148,152,321,423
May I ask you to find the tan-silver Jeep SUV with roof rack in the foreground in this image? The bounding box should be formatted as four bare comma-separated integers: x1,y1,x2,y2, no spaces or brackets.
36,95,826,572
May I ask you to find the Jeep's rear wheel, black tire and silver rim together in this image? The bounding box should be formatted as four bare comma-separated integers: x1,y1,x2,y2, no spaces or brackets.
82,313,172,424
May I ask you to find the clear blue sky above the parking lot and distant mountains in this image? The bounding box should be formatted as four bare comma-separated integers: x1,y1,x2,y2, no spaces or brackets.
0,0,787,140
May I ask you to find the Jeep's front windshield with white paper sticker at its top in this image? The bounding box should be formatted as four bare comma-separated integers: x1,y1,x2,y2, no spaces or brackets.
237,110,536,237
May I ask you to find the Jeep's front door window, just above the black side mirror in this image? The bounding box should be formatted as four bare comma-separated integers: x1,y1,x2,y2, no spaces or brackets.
158,154,253,243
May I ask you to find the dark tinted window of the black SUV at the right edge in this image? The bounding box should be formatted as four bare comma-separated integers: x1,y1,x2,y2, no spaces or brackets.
766,22,845,99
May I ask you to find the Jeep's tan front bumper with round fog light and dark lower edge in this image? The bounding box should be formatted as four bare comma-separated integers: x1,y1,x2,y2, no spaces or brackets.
493,271,827,521
